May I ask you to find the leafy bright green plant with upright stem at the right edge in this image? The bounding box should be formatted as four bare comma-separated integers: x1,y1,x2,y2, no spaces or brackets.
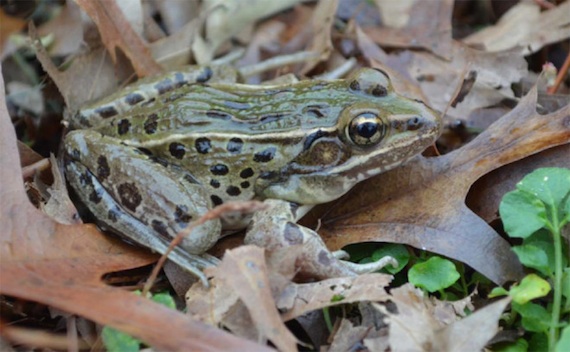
490,168,570,352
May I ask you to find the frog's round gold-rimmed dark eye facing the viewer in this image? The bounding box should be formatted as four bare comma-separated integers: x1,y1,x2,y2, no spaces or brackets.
347,112,387,147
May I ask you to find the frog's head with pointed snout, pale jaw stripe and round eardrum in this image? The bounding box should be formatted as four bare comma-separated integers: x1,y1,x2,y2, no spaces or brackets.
262,68,441,204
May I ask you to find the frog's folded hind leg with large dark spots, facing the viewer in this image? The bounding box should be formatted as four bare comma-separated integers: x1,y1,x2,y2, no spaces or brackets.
65,130,221,281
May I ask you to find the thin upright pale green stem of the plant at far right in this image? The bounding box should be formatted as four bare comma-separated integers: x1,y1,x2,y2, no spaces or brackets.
548,208,562,351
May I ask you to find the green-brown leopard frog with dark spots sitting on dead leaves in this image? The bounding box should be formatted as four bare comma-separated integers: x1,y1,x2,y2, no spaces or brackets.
63,66,441,283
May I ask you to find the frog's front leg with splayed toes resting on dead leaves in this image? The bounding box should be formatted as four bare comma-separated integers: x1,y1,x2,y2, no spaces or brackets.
245,199,397,279
